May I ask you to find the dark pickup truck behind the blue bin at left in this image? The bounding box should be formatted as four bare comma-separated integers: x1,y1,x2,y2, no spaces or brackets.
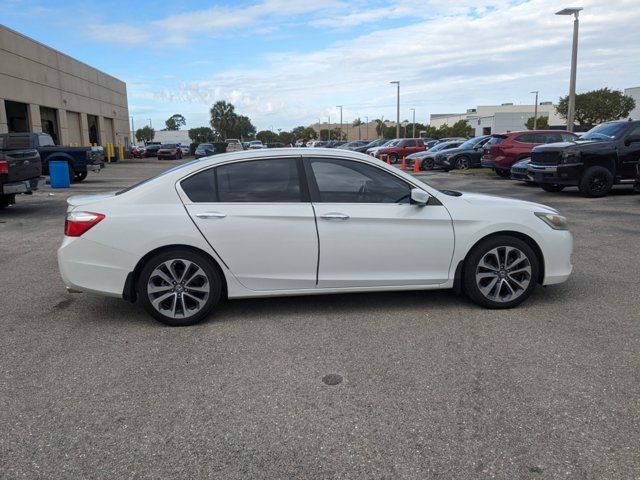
2,133,104,182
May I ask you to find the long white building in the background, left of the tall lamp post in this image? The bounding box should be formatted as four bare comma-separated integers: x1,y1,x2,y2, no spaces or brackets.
430,102,566,135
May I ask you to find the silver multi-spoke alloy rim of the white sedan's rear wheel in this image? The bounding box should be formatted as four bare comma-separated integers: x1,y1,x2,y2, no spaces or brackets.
147,258,211,318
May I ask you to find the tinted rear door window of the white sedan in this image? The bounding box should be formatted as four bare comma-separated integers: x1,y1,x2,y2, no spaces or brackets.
217,158,301,203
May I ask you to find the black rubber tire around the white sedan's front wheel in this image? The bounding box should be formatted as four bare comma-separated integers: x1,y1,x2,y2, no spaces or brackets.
462,235,540,309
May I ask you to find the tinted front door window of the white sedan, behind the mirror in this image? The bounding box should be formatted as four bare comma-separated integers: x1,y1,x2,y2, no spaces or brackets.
311,159,411,203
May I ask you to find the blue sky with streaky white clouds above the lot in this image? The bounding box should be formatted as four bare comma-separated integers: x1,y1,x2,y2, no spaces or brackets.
0,0,640,130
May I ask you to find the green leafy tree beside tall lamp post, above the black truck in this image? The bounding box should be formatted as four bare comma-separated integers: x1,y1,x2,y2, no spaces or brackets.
558,88,636,130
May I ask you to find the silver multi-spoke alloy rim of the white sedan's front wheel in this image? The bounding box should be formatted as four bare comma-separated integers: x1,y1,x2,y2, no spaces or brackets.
476,246,531,303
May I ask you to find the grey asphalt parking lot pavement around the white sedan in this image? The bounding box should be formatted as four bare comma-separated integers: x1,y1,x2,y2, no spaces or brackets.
0,159,640,479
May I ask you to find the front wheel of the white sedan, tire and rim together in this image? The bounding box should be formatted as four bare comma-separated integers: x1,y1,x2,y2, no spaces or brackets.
463,235,539,309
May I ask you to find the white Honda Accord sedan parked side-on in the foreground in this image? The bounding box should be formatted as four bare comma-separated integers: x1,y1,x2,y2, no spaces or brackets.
58,148,572,325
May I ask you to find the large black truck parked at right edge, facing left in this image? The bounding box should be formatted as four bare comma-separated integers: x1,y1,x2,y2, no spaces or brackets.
528,120,640,197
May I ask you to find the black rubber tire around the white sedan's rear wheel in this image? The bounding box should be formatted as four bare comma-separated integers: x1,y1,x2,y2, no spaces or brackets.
137,248,222,327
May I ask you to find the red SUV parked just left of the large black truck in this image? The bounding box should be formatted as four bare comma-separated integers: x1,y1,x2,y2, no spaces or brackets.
480,130,578,178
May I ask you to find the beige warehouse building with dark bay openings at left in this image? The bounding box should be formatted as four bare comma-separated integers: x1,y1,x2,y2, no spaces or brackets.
0,25,130,147
